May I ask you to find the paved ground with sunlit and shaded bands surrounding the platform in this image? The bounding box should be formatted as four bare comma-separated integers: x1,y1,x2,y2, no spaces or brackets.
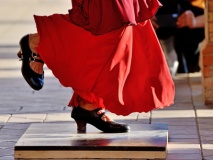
0,0,213,160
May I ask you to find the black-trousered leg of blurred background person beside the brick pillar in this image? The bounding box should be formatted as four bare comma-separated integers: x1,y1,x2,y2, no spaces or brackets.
174,28,204,73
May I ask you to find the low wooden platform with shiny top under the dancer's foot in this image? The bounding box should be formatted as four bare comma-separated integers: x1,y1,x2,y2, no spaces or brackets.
15,122,168,160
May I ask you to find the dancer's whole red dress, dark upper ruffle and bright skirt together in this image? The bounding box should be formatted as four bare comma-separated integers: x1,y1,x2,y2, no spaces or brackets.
34,0,174,115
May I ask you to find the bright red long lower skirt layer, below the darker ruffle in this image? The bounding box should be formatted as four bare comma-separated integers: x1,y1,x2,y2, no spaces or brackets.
35,14,174,115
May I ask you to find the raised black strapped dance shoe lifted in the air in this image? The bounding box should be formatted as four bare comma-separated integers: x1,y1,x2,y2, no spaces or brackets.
17,35,44,90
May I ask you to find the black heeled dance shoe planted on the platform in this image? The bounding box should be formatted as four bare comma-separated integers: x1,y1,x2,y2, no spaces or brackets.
71,107,130,133
